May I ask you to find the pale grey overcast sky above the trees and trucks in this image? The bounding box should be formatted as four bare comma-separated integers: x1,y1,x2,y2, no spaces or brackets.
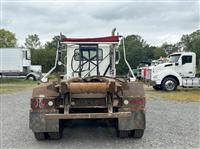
1,0,200,45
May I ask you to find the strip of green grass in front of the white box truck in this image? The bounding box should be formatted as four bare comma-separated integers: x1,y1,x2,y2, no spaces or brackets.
0,78,37,93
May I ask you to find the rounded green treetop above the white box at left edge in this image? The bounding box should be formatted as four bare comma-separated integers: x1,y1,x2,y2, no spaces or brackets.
0,29,17,48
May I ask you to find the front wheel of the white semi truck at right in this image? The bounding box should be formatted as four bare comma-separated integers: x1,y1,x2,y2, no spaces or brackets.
162,77,178,91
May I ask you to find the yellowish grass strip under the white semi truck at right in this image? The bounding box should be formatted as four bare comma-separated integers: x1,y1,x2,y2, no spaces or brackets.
144,86,200,102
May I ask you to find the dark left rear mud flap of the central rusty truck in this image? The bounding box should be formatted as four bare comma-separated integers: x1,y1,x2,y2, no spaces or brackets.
29,111,59,132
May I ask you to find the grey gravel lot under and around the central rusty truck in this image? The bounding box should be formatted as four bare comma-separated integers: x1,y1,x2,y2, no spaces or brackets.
0,91,200,149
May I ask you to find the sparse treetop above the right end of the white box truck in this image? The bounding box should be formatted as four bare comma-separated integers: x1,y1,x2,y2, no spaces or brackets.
24,34,41,49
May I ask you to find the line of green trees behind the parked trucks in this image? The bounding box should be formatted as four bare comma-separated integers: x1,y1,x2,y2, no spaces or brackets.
0,29,200,75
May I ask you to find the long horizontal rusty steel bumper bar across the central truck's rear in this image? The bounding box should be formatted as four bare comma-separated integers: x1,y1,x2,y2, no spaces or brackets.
46,112,131,119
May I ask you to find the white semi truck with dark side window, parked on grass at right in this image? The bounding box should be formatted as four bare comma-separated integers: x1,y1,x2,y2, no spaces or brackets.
145,52,200,91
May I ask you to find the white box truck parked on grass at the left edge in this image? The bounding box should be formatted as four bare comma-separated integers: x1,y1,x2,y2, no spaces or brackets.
0,48,42,80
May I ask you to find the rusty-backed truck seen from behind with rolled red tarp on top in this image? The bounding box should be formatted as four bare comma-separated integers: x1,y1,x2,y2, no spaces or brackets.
30,30,145,140
